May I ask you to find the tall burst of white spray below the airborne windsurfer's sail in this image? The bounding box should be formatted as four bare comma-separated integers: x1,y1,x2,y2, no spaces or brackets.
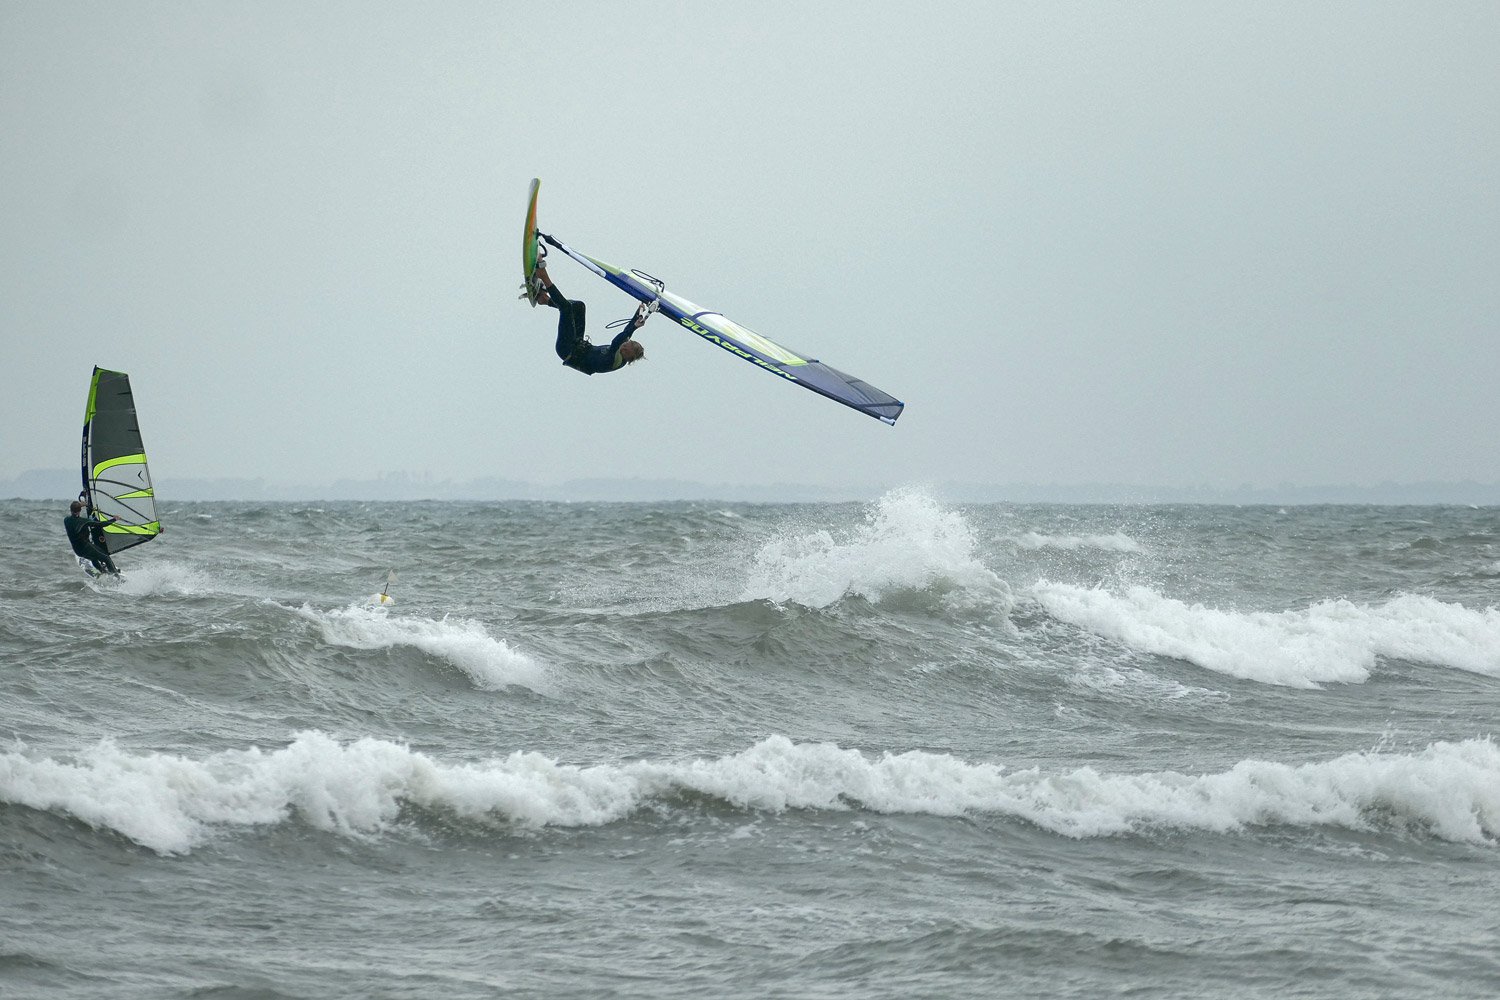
741,490,1011,612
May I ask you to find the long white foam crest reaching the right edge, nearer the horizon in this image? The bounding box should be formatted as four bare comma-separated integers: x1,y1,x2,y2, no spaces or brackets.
1032,582,1500,688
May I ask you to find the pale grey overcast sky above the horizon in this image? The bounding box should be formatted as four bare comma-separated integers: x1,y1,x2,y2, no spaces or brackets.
0,0,1500,486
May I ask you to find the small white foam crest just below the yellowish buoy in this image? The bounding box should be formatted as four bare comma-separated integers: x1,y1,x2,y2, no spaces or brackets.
297,604,551,694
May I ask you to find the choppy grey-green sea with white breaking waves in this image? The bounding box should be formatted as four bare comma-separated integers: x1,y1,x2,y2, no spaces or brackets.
0,487,1500,1000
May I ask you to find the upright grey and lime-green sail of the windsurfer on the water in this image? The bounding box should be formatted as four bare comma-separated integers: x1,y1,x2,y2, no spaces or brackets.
83,367,162,553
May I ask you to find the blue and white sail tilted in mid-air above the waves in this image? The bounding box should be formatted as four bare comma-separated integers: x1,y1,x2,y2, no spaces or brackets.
537,232,906,424
